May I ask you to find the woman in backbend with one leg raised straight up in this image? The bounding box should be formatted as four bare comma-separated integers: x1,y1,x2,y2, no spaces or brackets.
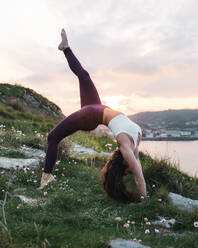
40,29,146,202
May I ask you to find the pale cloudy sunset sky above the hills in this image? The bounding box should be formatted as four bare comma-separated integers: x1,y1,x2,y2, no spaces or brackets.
0,0,198,115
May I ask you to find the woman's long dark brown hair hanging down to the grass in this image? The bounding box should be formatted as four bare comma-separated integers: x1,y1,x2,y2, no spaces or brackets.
100,149,140,203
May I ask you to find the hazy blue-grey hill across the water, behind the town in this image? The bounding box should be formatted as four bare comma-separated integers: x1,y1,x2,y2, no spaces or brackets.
129,109,198,128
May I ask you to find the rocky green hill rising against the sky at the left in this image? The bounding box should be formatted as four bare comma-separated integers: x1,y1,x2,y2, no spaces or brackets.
0,83,64,119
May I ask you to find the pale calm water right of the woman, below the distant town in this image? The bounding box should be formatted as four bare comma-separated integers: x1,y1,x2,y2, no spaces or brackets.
140,140,198,177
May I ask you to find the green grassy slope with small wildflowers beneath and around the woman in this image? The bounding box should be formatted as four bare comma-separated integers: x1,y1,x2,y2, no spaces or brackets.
0,91,198,248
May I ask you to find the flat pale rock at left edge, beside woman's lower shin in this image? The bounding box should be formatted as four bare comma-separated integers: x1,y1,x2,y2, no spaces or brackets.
0,157,40,169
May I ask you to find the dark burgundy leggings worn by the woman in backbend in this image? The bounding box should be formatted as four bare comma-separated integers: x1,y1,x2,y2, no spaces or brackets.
44,47,106,173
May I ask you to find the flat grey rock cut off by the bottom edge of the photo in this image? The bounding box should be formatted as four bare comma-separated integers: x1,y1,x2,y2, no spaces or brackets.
108,239,150,248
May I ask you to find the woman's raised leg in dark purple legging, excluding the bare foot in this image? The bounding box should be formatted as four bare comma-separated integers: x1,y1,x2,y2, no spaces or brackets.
63,47,101,107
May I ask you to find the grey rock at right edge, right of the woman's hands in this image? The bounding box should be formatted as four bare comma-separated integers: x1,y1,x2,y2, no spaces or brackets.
168,192,198,212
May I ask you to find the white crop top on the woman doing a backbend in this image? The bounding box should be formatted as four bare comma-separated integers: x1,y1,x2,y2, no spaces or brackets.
108,114,142,147
